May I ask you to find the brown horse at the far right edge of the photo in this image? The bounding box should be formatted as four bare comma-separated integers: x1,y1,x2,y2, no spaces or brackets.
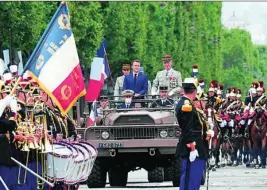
251,106,267,168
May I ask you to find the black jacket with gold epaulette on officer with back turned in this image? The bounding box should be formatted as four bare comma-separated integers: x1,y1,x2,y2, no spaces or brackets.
176,96,208,159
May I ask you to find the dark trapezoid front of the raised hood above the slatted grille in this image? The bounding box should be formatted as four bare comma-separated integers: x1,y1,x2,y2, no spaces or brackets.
114,115,154,125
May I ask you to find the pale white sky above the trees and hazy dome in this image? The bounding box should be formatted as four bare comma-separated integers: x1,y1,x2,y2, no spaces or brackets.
222,2,267,44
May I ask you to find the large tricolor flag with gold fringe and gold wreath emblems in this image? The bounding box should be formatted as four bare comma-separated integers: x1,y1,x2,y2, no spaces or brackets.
24,3,86,115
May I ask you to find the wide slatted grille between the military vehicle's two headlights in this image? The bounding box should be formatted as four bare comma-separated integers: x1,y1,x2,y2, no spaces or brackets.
110,127,158,140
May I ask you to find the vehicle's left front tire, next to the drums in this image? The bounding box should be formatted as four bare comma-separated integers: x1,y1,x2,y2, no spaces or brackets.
87,159,107,188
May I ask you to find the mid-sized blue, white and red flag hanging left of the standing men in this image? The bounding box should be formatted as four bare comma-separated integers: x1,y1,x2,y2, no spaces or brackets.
85,39,110,102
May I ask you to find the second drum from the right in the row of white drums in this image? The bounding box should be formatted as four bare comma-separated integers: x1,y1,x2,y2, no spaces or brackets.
74,143,90,182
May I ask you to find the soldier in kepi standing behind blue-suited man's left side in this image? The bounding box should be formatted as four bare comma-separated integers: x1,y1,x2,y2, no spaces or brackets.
114,63,131,100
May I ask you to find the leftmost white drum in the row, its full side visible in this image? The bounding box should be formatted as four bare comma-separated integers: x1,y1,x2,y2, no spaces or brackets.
46,142,73,181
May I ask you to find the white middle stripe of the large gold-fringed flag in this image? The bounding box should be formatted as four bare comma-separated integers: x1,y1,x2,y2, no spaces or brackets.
38,34,79,92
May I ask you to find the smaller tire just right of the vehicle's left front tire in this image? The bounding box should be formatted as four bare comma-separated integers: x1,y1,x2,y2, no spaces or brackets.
108,167,128,187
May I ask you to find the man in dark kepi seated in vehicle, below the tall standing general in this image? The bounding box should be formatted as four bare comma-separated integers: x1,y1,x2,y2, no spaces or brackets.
151,85,174,108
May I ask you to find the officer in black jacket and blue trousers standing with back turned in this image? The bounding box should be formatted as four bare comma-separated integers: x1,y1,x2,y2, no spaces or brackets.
176,78,214,190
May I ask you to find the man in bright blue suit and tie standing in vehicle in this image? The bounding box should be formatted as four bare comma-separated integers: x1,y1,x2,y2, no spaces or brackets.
122,60,148,98
